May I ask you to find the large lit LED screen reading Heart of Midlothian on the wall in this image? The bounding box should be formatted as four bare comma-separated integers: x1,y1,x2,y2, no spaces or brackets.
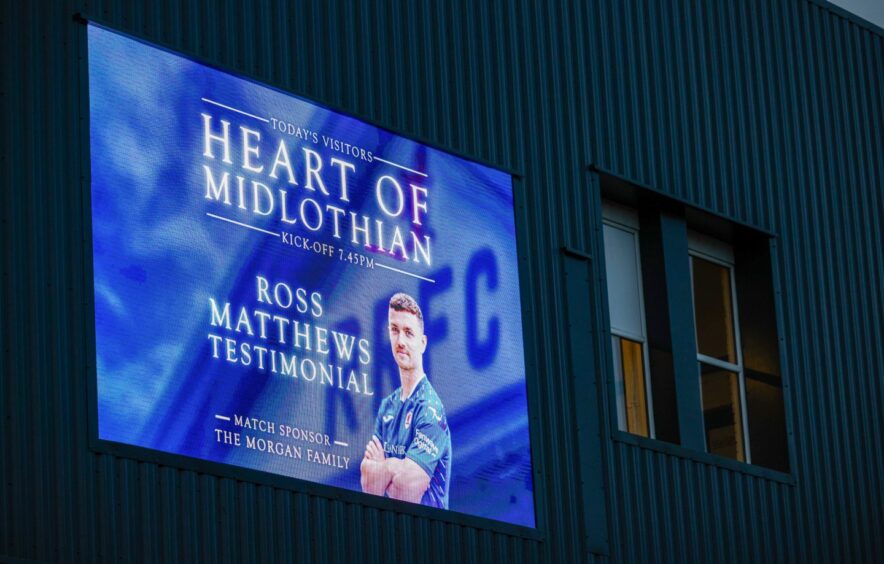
88,25,535,527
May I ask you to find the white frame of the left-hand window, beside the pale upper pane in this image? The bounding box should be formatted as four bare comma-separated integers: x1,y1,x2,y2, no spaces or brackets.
602,201,657,439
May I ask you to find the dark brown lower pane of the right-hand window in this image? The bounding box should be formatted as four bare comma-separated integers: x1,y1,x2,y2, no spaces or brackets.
700,363,745,462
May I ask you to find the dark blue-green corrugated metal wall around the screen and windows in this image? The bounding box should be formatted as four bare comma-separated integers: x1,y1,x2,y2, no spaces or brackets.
0,0,884,563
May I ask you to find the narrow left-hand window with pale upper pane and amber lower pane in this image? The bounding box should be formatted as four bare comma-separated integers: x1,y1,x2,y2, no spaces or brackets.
604,204,654,437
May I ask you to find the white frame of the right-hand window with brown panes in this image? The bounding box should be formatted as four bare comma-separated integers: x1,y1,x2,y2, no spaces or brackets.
688,231,752,464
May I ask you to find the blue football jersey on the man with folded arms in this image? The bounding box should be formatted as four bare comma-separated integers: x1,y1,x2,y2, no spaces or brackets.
374,377,451,509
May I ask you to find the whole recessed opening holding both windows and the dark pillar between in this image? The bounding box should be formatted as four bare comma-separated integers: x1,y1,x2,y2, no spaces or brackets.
602,184,789,472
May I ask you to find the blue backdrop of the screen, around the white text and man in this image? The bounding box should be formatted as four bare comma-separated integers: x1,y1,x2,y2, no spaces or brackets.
88,25,535,527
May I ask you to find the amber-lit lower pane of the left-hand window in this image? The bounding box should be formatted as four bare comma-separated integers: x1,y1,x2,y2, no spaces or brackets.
614,337,650,437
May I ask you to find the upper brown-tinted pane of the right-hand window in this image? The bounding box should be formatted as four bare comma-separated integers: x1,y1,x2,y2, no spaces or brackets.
691,257,737,364
